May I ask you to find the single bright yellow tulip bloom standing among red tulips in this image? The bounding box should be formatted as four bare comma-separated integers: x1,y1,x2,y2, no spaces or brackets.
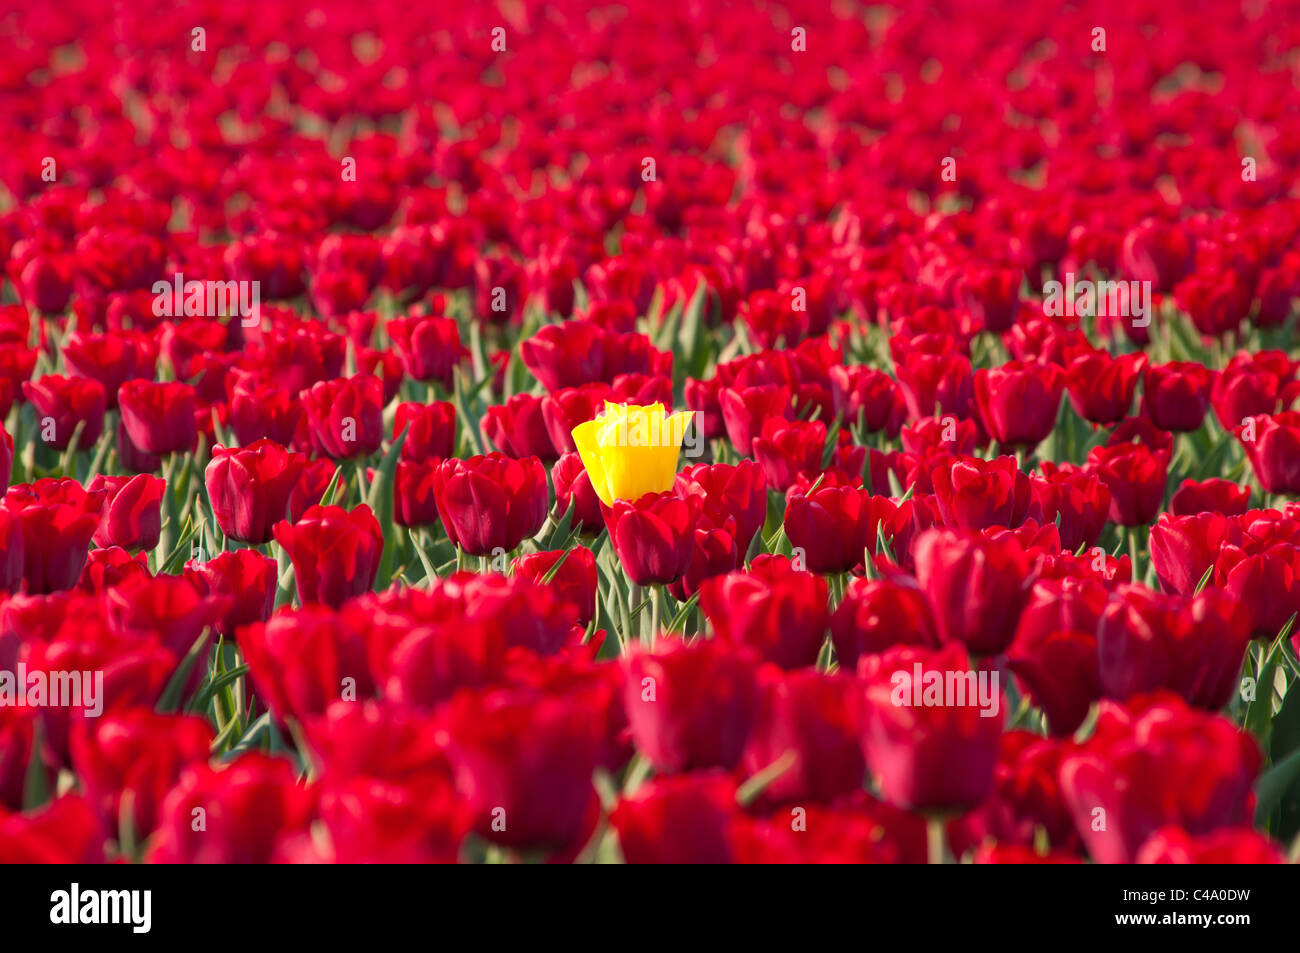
573,400,694,506
